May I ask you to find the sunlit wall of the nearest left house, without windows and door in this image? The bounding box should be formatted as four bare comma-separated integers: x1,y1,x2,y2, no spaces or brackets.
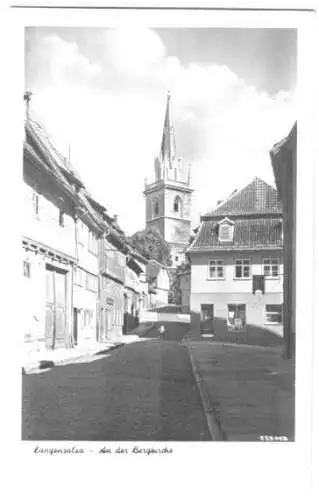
21,158,75,351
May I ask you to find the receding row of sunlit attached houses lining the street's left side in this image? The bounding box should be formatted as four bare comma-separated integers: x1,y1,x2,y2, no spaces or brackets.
22,102,149,354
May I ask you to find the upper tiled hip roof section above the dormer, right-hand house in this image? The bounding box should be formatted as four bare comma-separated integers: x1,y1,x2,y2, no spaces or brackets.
205,177,282,220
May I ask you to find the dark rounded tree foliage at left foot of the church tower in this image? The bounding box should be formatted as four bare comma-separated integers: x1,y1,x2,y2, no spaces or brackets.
130,227,172,266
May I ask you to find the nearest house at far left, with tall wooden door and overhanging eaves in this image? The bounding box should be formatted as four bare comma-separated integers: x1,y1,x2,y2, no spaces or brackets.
22,119,76,351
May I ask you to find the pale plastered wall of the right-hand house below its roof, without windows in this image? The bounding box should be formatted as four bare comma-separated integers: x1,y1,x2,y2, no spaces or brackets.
190,250,283,336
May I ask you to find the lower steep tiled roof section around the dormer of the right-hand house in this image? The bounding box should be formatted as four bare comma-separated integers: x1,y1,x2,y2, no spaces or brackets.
189,216,283,253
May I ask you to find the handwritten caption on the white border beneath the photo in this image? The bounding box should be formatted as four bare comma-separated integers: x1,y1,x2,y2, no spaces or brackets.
33,446,173,455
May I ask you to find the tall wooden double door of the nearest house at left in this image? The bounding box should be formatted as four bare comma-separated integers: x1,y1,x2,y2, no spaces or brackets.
45,265,66,349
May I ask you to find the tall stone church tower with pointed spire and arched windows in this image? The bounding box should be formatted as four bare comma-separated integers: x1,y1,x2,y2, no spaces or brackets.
144,93,193,267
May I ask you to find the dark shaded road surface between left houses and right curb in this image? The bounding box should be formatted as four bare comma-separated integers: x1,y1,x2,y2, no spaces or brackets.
22,338,210,441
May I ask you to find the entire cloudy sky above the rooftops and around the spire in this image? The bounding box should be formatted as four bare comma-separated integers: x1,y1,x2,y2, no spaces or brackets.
25,27,297,234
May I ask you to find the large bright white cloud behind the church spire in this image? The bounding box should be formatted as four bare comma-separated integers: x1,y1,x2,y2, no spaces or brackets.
26,29,294,232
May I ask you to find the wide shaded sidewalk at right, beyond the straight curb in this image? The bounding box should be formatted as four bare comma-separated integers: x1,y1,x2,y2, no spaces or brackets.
186,340,294,441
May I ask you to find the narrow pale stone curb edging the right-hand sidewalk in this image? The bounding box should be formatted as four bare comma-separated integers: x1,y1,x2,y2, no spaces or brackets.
184,342,227,441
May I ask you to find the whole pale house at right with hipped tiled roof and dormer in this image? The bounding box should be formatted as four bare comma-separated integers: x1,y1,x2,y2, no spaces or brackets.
188,177,283,336
